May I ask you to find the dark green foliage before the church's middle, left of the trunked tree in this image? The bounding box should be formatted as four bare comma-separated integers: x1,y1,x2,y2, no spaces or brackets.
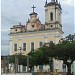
28,43,56,65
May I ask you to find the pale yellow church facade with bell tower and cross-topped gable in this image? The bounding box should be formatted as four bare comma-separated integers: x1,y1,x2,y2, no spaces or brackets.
10,0,63,72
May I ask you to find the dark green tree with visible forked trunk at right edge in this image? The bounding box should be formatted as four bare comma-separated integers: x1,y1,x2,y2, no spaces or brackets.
55,41,75,75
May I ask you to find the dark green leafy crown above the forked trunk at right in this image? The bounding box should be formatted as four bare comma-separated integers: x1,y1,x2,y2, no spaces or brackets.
55,41,75,60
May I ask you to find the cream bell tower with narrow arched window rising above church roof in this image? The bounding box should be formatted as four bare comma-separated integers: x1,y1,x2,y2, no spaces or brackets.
45,0,62,30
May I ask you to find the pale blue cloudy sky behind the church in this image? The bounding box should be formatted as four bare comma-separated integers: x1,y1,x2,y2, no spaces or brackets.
1,0,75,55
